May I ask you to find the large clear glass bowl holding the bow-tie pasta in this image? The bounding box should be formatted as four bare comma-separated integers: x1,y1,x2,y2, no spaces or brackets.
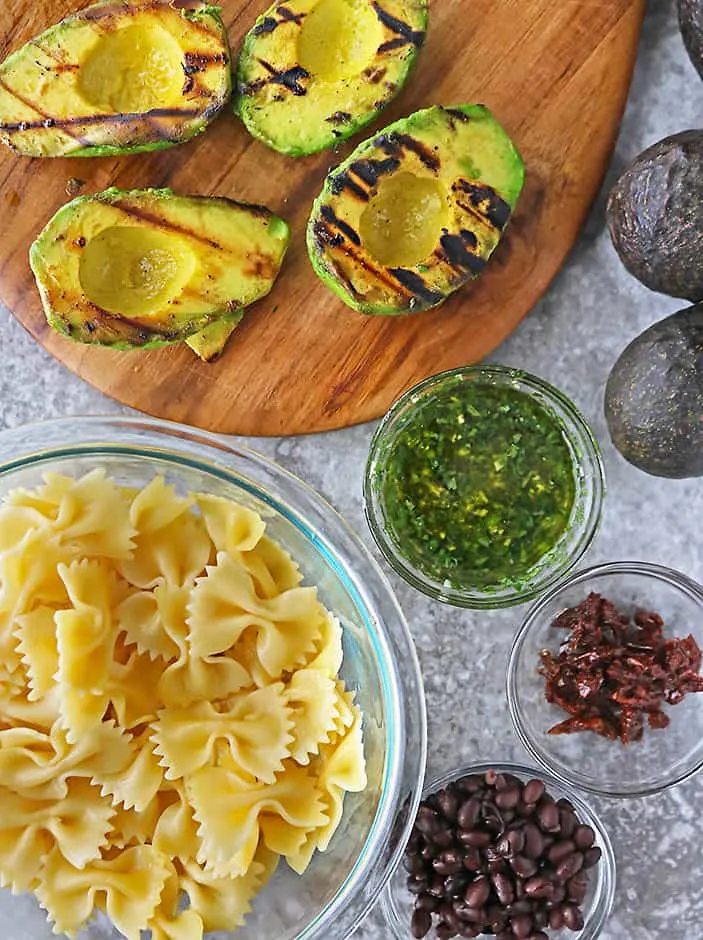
0,418,426,940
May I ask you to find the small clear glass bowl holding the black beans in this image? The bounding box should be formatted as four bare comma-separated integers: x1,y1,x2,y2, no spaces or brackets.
381,763,616,940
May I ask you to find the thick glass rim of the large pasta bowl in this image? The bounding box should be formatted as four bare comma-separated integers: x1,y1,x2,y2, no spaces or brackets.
0,414,427,940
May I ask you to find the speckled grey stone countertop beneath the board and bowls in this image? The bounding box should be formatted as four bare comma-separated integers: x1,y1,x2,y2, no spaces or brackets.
0,0,703,940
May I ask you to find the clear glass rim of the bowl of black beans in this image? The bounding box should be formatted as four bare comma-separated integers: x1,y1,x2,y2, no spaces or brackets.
380,761,617,940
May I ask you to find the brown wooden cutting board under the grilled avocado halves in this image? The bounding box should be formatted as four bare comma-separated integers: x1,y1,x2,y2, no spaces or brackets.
0,0,645,435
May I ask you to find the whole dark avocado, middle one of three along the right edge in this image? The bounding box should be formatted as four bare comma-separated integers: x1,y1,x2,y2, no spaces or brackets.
607,130,703,303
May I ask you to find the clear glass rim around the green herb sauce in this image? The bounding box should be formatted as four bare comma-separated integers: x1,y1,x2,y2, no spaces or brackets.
363,363,606,610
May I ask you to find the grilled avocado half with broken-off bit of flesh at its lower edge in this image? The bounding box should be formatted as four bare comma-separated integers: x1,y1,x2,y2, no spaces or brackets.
30,189,290,348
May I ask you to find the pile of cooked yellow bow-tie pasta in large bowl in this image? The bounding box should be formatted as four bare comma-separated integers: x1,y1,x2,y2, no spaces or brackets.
0,471,366,940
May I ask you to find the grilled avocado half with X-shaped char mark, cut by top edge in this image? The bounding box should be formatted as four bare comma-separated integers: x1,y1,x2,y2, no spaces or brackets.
235,0,427,156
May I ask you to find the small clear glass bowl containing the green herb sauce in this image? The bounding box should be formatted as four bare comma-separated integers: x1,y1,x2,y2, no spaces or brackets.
364,365,605,610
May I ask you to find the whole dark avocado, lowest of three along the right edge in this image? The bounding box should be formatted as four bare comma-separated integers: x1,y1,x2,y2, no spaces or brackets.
605,304,703,479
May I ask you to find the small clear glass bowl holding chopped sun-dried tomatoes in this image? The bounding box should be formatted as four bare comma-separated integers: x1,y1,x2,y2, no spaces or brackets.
508,561,703,797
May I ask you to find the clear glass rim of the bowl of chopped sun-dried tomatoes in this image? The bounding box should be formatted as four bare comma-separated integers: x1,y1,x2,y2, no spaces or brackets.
506,561,703,799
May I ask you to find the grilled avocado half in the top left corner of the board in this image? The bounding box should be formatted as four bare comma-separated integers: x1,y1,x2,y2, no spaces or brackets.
0,0,232,157
